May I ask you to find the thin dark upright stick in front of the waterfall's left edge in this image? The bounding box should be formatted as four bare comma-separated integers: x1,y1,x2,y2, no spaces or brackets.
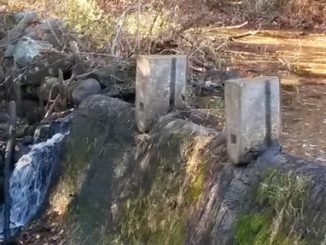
3,101,17,242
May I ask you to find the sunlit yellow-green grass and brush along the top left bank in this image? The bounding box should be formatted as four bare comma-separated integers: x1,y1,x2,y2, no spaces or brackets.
0,0,176,51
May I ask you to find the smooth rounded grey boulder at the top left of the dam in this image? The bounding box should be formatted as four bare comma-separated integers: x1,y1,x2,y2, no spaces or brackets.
72,78,101,105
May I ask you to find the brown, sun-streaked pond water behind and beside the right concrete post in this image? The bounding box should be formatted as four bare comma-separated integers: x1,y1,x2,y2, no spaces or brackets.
192,28,326,164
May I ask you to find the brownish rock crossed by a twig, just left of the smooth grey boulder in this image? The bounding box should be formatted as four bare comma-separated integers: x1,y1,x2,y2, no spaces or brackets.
40,76,60,102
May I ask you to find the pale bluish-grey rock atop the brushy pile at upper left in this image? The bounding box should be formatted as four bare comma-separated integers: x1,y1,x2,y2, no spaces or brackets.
13,37,53,67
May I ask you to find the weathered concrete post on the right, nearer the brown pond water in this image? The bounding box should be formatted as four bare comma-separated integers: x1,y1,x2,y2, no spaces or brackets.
225,77,281,165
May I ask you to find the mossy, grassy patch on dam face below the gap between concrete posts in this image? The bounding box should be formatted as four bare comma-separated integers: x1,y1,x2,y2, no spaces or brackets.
115,130,207,245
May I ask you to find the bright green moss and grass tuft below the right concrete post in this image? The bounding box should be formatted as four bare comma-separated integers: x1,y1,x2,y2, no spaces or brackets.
235,169,309,245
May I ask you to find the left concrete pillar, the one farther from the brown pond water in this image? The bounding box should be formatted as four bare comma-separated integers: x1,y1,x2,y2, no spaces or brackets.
136,55,187,132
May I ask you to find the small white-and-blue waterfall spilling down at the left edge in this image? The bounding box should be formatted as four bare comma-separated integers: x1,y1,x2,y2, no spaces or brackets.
0,120,69,239
